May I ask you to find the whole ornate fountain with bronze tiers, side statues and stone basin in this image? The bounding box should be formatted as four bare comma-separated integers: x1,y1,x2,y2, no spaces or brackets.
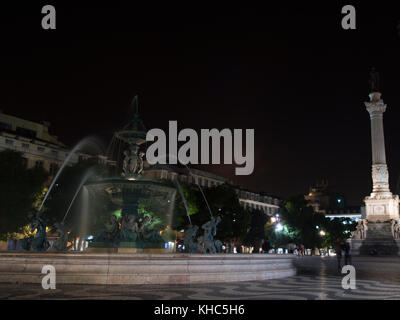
0,97,296,285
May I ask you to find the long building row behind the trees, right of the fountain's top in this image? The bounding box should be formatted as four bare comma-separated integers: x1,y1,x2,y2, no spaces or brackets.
143,164,280,216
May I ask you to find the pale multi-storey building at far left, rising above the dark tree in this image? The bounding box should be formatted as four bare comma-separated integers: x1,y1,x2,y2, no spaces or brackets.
0,111,90,175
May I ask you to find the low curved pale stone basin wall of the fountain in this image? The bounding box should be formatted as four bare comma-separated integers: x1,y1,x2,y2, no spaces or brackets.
0,252,296,286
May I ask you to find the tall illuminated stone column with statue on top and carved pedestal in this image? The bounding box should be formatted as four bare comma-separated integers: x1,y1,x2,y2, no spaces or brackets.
351,69,400,255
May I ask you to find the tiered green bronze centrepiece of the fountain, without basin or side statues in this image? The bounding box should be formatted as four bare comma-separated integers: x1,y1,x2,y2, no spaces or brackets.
85,105,176,252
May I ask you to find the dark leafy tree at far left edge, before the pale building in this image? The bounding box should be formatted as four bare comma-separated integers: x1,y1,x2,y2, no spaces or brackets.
0,150,48,239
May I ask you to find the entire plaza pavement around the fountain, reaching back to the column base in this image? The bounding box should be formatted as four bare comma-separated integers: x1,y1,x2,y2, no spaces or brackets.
0,257,400,300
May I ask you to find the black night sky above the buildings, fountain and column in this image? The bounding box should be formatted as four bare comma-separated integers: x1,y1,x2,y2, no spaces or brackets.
0,1,400,205
